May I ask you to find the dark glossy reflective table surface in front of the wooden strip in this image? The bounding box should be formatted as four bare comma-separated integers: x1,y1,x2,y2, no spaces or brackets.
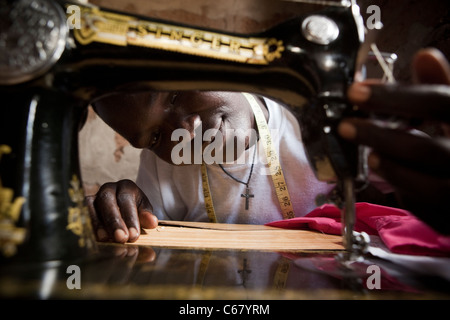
0,243,450,300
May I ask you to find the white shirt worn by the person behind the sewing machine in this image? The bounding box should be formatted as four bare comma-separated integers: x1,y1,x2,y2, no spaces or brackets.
136,99,334,224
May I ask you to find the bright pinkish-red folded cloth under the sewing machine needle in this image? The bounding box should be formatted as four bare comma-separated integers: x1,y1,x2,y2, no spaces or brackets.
266,202,450,256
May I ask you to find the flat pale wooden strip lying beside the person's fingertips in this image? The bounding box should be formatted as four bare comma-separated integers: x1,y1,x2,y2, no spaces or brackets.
133,221,344,251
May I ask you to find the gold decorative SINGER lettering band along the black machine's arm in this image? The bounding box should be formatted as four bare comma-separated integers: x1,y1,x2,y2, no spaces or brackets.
74,6,285,65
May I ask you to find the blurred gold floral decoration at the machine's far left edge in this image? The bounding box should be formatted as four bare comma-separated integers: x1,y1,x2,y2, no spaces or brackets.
0,144,26,257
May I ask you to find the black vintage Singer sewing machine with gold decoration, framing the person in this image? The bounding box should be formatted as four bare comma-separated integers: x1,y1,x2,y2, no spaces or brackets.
0,0,428,300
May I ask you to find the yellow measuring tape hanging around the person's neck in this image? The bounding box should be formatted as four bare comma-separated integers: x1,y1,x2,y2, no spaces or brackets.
201,93,295,222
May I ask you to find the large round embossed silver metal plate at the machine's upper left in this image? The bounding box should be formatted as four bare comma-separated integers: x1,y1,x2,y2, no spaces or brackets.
0,0,68,85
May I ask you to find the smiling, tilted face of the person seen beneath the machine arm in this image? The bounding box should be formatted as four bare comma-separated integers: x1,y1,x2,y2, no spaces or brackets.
93,91,255,163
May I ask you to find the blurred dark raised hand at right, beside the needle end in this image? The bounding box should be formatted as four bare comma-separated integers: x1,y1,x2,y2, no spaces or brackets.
338,49,450,233
